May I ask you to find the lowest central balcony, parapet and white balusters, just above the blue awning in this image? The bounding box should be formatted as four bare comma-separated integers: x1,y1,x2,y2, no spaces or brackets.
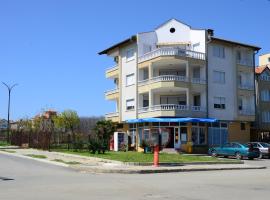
138,104,206,118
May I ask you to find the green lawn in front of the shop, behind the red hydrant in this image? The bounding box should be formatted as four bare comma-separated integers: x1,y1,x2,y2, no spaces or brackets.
51,149,239,163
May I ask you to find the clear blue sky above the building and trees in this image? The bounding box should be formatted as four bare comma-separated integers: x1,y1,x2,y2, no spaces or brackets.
0,0,270,120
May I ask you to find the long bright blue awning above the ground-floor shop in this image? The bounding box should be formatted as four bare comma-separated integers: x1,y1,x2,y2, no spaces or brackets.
126,117,217,124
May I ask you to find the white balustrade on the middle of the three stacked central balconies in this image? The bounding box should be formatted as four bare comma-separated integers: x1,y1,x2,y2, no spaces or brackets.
138,75,193,85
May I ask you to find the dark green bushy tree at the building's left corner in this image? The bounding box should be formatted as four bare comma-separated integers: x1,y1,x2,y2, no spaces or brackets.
94,120,117,153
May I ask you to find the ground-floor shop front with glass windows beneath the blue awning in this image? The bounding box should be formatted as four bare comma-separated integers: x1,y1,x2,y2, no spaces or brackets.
114,121,250,153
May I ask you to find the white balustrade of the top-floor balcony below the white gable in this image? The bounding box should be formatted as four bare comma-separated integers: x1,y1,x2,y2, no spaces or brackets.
138,47,205,63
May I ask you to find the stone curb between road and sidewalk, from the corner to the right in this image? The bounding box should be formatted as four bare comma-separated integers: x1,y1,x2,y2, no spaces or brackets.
73,166,266,174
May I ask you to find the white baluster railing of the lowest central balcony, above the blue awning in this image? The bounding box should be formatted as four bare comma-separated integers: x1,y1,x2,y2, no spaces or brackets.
138,104,206,113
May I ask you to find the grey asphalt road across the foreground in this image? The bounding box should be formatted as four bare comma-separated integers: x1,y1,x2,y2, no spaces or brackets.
0,154,270,200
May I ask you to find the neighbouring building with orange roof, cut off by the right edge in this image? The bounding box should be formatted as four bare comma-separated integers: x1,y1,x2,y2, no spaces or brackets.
252,54,270,142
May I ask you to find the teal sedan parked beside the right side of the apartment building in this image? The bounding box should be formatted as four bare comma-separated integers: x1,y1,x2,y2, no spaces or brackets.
208,142,260,159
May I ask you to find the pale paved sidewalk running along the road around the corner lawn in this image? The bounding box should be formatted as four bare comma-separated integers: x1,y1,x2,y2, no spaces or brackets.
0,149,266,174
